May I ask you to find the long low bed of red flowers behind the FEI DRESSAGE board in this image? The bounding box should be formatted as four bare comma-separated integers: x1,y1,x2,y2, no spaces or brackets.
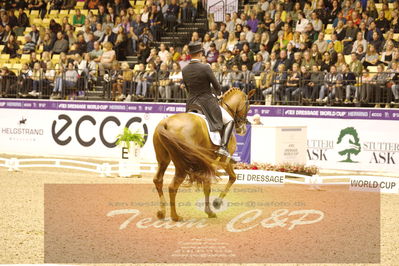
234,163,319,175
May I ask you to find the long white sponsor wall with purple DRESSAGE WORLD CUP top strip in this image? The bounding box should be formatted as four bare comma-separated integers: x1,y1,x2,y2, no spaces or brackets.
0,99,399,173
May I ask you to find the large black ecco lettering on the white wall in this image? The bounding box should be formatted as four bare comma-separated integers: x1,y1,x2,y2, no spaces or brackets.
51,114,148,148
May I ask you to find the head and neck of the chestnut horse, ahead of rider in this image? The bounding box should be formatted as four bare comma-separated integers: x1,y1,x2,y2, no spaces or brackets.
222,88,256,136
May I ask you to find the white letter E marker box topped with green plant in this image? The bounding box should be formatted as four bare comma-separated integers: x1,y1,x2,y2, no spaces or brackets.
116,127,145,177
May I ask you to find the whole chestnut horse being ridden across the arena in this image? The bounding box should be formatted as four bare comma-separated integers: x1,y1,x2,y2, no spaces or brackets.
153,88,255,221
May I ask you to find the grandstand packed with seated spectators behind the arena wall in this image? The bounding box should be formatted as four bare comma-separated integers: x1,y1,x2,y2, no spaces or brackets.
0,0,399,107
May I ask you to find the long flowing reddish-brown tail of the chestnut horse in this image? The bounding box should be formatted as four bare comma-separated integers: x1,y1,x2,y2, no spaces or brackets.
156,123,223,185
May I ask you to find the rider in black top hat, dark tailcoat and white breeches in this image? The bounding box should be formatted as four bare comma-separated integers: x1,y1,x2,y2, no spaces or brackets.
182,42,234,157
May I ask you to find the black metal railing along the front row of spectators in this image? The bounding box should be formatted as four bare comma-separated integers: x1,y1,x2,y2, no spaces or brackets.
0,70,399,107
